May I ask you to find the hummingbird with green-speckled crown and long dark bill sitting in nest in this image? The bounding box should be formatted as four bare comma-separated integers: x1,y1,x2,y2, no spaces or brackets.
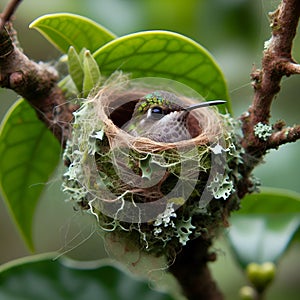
123,90,226,143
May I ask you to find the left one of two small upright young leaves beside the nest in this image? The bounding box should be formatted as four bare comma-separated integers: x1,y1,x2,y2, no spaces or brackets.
68,46,84,92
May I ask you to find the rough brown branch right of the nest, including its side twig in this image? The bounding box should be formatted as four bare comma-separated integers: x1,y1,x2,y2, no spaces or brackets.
238,0,300,198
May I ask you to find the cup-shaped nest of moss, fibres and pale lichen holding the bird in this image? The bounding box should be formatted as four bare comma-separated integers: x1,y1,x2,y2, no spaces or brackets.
63,74,240,256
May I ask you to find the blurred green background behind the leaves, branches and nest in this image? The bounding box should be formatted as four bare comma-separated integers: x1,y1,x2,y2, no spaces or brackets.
0,0,300,300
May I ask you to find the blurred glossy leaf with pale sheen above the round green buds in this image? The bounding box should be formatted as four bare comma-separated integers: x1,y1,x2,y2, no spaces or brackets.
228,188,300,267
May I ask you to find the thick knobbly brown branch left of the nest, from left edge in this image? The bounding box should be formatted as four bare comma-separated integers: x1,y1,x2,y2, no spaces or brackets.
0,25,74,146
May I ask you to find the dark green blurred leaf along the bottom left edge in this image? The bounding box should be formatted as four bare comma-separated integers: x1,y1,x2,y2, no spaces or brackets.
0,254,173,300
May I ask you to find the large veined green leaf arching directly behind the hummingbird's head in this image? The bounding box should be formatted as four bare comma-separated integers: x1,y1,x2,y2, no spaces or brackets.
94,31,231,112
